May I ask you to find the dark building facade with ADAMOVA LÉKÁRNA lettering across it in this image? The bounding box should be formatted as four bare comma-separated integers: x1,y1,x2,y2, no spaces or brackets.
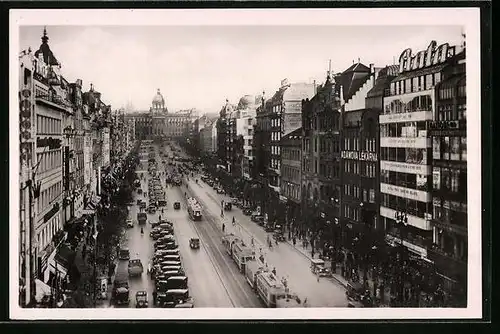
340,63,379,247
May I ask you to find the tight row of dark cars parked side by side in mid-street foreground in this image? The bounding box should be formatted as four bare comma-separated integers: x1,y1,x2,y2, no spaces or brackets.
148,220,194,308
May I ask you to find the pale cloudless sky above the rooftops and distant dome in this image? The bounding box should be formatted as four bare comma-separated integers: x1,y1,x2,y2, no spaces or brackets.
19,25,462,113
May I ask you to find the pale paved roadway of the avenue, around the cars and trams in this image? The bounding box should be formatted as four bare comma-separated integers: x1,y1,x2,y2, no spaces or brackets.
102,141,347,307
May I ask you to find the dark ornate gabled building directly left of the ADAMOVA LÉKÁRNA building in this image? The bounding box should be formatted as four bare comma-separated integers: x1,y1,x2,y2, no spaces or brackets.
295,74,344,247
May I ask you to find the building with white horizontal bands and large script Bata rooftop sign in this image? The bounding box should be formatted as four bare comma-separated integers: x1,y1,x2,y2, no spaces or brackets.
379,41,455,258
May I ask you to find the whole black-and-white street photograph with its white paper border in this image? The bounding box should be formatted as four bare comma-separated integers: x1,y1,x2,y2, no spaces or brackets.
9,8,482,320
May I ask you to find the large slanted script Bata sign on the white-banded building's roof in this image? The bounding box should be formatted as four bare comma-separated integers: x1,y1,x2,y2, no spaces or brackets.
399,41,455,73
